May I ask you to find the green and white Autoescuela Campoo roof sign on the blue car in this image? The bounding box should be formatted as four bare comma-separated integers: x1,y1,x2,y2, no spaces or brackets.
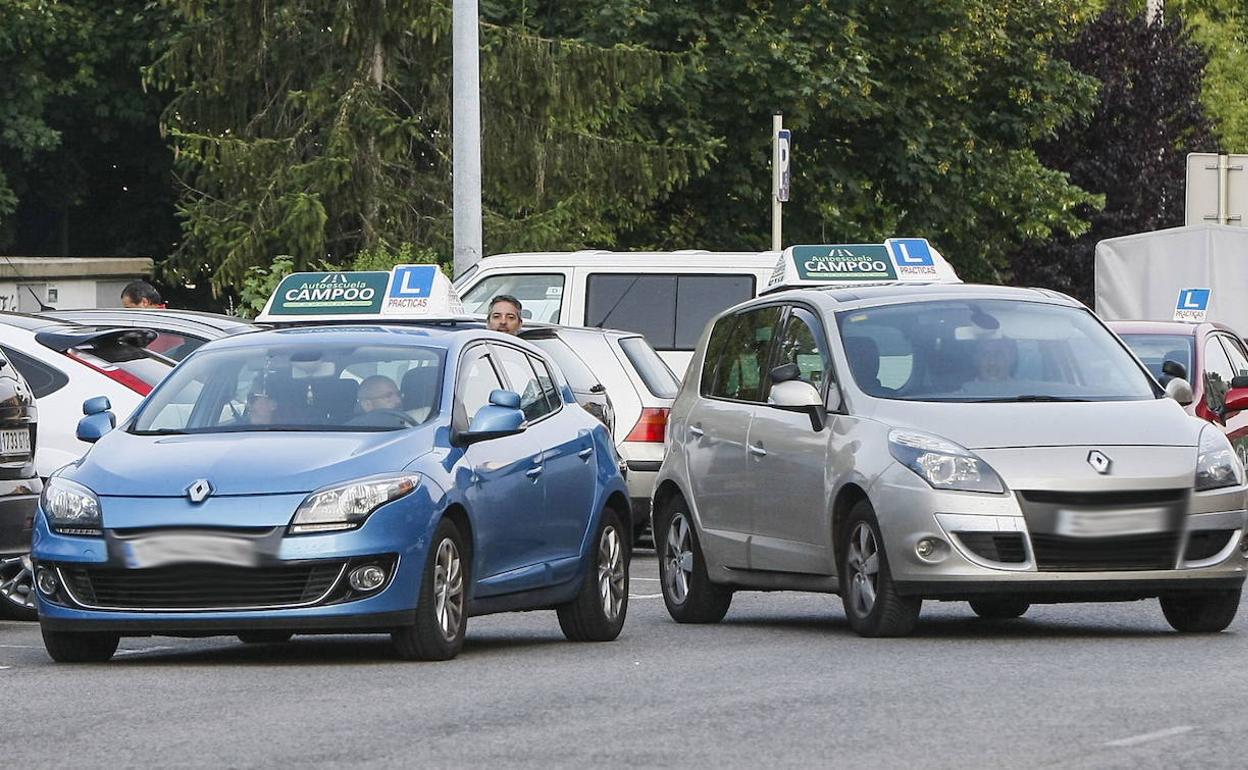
257,265,463,321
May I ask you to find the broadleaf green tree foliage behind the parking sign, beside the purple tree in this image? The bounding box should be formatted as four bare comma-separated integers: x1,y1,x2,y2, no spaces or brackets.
525,0,1098,280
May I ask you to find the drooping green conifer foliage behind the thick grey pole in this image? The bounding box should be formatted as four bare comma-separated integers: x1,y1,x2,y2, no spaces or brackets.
150,0,710,288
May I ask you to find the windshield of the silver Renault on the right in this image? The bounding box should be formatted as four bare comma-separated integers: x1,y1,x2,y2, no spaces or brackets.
836,300,1157,402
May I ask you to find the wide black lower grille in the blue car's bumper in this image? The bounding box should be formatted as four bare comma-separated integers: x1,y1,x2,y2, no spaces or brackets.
60,559,346,610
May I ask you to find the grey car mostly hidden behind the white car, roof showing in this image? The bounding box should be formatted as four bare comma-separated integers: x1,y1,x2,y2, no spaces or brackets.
41,307,257,361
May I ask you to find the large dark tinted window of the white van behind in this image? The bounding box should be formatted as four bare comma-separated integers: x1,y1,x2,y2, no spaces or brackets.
585,273,754,351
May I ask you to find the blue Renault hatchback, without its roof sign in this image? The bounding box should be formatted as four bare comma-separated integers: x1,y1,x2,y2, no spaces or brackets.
32,324,631,661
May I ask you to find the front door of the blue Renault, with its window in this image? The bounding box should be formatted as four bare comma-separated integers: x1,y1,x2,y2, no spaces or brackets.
454,344,545,595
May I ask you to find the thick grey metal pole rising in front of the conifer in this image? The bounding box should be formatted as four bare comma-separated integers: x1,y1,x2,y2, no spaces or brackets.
451,0,482,276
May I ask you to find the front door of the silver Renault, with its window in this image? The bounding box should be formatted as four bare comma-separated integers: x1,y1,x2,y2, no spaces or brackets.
746,307,835,574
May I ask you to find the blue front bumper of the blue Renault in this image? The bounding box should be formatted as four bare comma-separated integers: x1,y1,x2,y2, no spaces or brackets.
32,500,428,635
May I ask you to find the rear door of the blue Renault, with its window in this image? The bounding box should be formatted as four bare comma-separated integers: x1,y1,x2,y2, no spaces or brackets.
494,344,595,571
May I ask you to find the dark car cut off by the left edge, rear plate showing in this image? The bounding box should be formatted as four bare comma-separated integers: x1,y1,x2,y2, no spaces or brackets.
0,344,44,620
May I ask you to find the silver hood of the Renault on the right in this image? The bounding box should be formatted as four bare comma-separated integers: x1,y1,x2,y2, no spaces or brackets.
876,398,1206,449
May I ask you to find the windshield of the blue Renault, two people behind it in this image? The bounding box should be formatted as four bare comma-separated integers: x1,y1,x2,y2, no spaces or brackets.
131,343,444,434
